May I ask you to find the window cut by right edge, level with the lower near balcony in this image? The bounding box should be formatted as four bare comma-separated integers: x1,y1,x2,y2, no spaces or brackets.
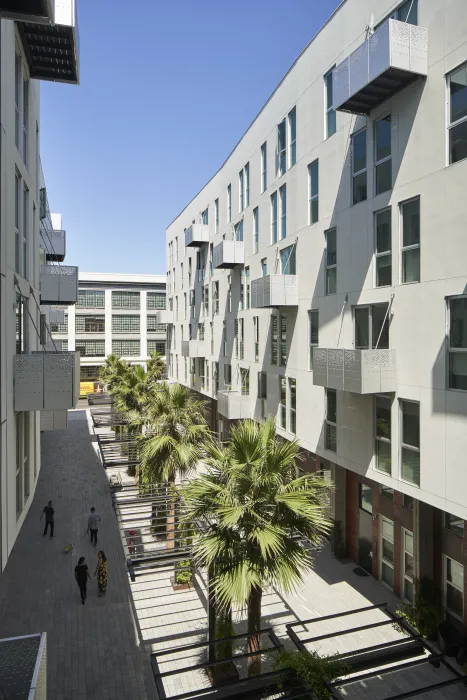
448,297,467,391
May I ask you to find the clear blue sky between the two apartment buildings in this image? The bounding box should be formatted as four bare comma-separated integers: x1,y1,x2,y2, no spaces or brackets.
41,0,340,274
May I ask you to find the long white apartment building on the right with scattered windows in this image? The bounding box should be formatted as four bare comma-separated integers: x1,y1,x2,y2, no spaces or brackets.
167,0,467,622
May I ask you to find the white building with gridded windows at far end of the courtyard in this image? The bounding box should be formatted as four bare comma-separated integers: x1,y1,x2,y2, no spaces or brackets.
51,272,166,394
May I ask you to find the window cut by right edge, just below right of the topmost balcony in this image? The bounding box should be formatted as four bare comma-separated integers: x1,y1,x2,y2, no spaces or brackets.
447,63,467,164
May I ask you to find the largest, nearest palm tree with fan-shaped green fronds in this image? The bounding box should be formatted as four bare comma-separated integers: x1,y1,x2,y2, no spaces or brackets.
182,418,331,675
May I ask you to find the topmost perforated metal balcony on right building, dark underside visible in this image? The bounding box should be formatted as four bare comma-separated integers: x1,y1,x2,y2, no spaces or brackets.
332,19,428,115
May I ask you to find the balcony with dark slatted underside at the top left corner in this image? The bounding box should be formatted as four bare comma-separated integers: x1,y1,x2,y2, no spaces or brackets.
17,0,79,84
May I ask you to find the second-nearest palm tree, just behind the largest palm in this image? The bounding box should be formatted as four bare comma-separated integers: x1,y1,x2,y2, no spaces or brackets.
141,382,209,549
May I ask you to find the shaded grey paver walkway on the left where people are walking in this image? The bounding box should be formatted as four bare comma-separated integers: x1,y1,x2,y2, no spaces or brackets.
0,410,156,700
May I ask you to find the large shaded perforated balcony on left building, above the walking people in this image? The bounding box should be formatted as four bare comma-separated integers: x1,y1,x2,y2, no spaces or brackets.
14,352,80,411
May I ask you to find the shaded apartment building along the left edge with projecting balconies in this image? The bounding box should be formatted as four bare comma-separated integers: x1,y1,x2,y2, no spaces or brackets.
0,0,78,571
